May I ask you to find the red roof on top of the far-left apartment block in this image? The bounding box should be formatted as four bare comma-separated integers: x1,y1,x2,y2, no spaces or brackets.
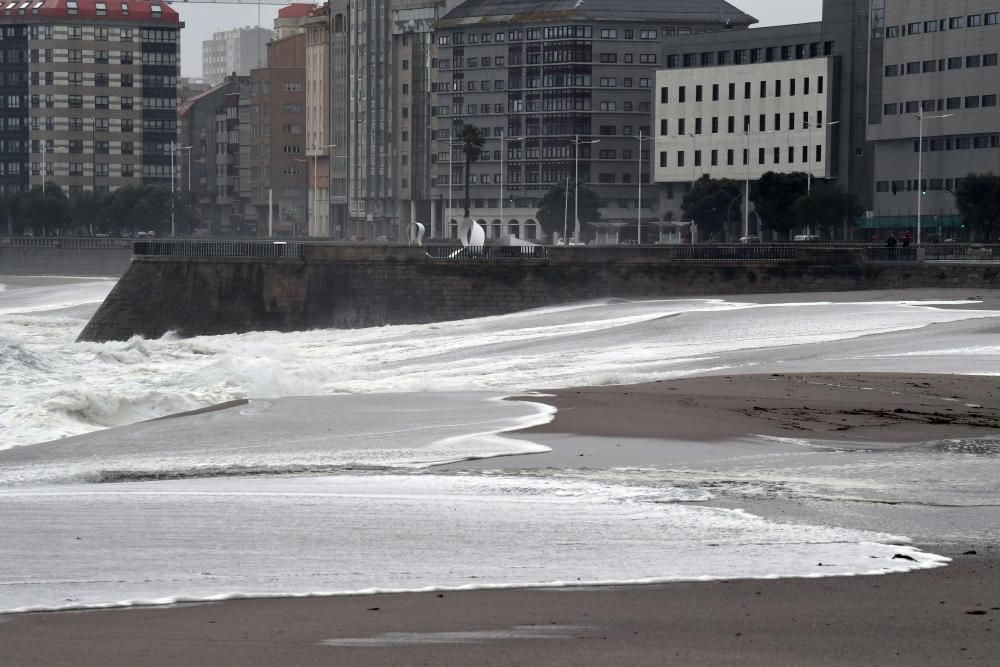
0,0,180,23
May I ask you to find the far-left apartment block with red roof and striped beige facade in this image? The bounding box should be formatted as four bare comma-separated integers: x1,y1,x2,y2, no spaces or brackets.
0,0,183,193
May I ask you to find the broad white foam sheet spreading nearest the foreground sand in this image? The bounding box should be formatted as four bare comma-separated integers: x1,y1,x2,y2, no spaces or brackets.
0,475,947,612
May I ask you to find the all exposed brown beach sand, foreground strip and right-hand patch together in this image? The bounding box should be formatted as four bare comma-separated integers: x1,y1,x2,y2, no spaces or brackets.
0,373,1000,665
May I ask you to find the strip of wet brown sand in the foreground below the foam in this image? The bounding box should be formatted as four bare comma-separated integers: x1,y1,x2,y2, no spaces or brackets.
0,546,1000,666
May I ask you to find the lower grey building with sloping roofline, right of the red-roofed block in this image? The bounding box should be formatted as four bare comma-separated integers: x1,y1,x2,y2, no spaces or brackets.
177,76,249,236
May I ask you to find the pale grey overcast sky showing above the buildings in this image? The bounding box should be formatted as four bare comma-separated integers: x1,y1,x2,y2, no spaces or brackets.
173,0,823,76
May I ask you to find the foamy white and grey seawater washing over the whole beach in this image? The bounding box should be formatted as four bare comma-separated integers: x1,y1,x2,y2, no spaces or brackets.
0,278,1000,611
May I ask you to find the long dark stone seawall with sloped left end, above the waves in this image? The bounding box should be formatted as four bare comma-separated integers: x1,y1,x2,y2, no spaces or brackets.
74,245,1000,341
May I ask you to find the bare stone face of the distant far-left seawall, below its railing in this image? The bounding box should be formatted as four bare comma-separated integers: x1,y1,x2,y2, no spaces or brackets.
0,244,132,276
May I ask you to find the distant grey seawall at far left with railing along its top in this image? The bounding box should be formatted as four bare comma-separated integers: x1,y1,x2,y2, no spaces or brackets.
0,239,132,276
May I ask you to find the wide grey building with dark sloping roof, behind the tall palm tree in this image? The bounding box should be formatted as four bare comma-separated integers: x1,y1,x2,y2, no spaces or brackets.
430,0,754,243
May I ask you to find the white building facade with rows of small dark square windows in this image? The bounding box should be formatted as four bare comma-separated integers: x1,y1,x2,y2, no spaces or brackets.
653,56,838,189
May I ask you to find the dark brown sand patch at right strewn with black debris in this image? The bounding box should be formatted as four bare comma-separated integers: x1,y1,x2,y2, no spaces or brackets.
529,373,1000,443
